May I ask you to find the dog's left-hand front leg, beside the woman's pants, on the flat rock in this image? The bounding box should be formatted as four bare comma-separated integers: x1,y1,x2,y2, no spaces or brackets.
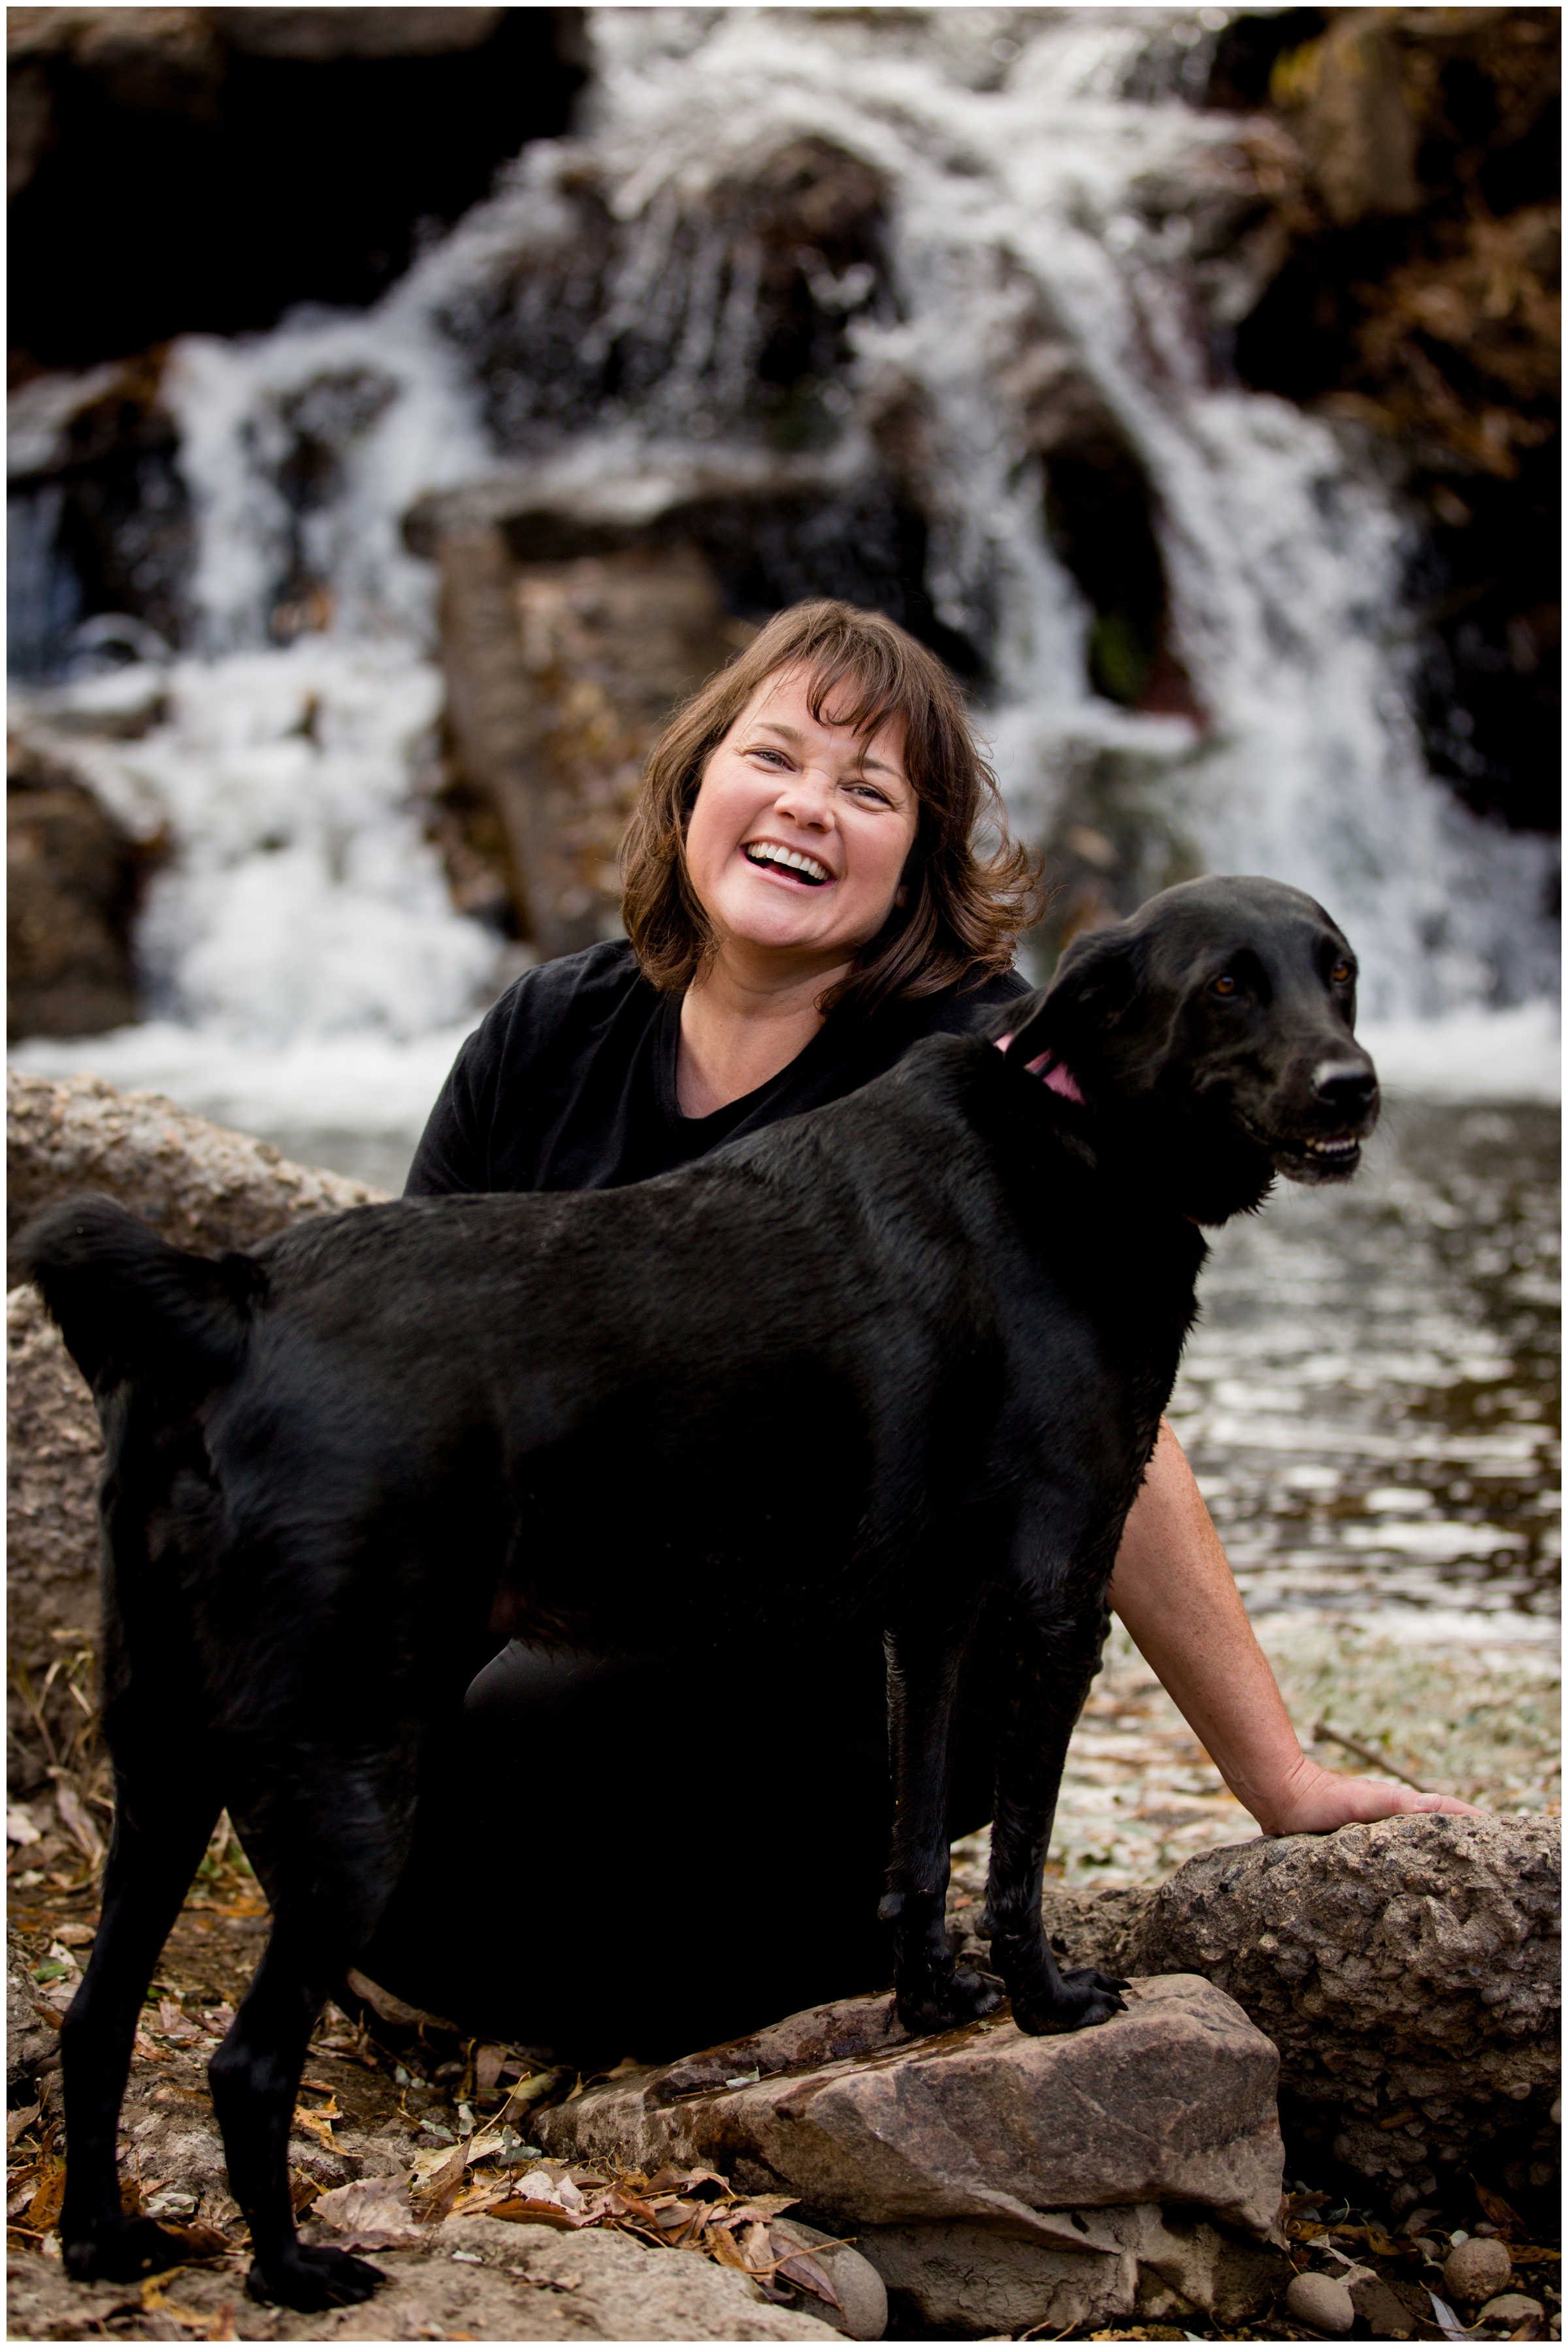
878,1630,1002,2034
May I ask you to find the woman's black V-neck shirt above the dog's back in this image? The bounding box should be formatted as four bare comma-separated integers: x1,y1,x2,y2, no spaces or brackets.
404,939,1028,1197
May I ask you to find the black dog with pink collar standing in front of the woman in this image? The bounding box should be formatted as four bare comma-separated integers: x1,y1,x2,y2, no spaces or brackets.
28,880,1378,2308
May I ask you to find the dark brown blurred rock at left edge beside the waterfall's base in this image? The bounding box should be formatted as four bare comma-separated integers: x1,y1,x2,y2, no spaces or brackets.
5,737,146,1040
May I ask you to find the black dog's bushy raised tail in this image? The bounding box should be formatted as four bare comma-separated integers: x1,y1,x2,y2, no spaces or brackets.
14,1197,268,1387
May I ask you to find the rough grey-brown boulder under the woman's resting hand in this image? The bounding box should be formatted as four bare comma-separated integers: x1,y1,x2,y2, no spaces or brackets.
1115,1817,1561,2198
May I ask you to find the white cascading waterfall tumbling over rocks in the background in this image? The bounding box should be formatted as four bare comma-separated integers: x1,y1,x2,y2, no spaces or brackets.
16,9,1552,1165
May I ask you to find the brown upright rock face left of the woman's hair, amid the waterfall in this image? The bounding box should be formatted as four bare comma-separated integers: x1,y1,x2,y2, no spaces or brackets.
439,537,744,958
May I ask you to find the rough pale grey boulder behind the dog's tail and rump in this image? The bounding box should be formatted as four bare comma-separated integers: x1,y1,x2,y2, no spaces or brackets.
7,1073,378,1796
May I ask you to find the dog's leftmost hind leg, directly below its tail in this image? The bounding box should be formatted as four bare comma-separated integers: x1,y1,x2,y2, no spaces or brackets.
61,1754,221,2282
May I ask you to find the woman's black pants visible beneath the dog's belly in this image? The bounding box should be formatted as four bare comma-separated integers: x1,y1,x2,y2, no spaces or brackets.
361,1625,993,2064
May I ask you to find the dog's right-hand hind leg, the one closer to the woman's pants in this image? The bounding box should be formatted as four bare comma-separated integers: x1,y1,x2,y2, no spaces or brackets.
206,1745,408,2315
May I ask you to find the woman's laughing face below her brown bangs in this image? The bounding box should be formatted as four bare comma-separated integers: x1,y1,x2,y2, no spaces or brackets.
685,669,920,972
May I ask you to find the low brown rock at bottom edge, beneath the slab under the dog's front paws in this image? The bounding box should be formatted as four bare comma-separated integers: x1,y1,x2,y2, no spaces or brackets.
857,2202,1291,2339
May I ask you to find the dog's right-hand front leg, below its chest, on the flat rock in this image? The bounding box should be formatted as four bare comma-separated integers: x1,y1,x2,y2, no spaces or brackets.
981,1608,1127,2036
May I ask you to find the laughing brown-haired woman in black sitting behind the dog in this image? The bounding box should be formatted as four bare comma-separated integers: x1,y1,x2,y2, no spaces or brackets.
366,603,1462,2057
